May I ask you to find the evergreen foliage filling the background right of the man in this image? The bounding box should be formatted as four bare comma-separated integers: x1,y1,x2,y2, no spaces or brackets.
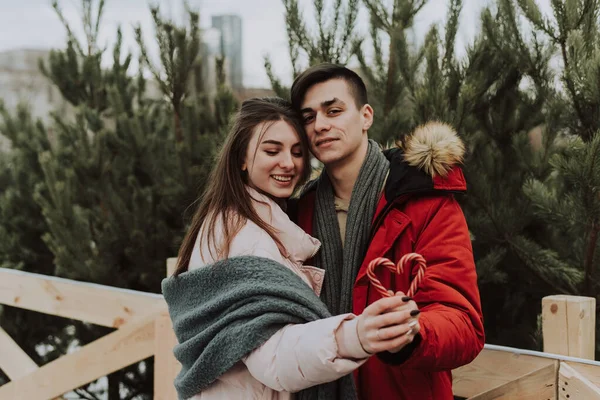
274,0,600,349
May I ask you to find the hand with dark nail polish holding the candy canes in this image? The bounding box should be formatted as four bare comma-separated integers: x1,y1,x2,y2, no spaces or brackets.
357,292,421,354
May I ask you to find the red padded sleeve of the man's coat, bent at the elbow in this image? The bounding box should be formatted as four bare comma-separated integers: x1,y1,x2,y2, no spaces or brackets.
380,195,485,370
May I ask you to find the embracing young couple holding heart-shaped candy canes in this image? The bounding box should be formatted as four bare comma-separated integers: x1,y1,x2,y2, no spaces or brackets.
163,64,484,400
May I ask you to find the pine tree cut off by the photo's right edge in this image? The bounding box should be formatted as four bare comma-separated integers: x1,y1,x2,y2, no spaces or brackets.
517,0,600,310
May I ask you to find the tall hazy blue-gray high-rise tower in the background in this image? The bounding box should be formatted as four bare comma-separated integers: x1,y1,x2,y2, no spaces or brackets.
212,15,244,90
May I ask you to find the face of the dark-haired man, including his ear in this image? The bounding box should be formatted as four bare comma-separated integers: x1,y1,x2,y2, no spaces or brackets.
301,79,373,166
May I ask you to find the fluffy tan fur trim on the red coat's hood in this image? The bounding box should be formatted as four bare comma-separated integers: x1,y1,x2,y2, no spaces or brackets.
402,122,465,177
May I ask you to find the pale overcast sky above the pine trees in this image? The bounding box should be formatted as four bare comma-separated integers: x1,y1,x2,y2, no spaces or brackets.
0,0,549,87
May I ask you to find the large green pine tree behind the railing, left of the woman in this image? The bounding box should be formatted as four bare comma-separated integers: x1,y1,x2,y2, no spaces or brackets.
0,0,237,399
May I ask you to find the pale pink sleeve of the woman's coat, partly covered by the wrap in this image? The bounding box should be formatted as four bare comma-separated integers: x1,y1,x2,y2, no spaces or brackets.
229,228,369,392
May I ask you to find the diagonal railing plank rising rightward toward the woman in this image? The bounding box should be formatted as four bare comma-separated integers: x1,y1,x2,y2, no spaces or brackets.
0,315,156,400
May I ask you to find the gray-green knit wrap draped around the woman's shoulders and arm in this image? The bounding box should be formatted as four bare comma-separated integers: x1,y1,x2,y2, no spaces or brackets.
162,256,353,400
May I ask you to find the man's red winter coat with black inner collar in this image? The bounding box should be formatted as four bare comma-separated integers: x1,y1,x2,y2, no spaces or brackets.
297,133,484,400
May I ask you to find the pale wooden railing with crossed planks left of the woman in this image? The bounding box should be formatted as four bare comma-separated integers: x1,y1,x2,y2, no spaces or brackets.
0,262,178,400
